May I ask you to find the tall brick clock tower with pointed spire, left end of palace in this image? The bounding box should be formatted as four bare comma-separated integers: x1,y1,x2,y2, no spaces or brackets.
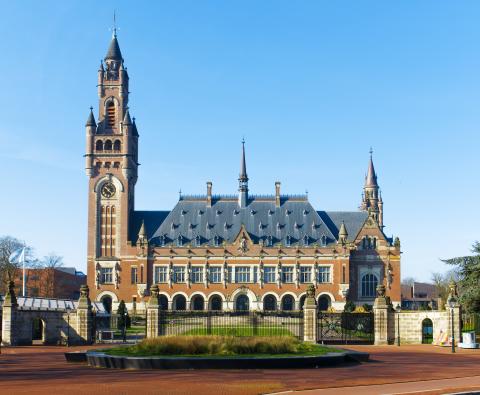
85,29,138,270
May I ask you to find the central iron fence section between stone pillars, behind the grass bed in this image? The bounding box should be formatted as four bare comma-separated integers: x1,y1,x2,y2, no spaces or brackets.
159,310,303,339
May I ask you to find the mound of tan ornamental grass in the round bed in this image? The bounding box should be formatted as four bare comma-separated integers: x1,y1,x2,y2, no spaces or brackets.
126,336,305,355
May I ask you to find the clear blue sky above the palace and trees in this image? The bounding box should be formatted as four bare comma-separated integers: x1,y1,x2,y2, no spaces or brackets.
0,0,480,280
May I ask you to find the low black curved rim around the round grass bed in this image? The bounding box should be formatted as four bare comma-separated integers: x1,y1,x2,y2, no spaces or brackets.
87,350,369,369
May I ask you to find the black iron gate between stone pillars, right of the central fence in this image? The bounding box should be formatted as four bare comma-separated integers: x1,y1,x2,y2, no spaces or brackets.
317,311,375,344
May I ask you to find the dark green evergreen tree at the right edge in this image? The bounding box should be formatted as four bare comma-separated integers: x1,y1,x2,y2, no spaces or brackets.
443,241,480,313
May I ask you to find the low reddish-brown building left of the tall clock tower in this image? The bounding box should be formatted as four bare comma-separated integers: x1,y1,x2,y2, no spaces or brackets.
15,267,87,299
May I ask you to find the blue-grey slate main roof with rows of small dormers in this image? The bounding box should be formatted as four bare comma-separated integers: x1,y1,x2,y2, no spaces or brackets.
130,196,368,246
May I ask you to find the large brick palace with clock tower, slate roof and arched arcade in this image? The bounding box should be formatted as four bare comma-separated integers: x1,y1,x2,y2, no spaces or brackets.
85,34,400,312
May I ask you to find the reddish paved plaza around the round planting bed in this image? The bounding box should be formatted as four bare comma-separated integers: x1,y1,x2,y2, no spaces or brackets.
0,345,480,395
